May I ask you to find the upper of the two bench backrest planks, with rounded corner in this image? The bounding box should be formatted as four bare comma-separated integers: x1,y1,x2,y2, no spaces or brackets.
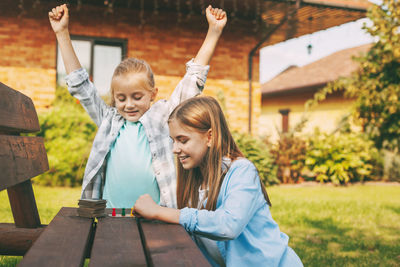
0,82,40,133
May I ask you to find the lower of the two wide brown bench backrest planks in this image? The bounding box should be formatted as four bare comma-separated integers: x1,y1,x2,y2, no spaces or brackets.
0,135,49,191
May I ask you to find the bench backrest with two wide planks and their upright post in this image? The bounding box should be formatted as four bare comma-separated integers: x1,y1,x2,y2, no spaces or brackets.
0,83,49,228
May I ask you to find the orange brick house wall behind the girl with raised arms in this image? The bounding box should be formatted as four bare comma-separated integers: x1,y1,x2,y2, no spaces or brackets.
0,0,261,132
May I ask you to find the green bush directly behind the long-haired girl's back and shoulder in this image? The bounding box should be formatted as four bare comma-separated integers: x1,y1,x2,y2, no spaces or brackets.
232,132,279,185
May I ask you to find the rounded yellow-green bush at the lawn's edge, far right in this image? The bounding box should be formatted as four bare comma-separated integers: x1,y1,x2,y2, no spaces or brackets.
303,130,381,184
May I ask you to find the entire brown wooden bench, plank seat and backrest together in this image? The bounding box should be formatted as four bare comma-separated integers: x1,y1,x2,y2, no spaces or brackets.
0,83,209,267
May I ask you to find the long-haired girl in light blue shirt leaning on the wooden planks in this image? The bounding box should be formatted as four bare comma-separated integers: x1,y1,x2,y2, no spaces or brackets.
134,97,302,267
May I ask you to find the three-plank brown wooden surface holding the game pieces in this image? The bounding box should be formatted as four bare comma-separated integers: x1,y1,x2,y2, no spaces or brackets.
18,207,210,267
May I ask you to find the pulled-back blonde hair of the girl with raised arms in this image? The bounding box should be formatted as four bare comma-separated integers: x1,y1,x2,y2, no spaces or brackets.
110,58,155,107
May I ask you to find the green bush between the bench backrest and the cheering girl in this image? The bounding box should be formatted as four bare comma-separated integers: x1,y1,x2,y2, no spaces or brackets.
34,88,97,186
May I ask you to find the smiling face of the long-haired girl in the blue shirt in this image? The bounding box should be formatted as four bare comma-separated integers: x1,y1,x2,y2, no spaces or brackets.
168,119,211,170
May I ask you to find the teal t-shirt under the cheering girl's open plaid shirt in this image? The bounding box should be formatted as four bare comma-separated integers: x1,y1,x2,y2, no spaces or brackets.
103,121,160,208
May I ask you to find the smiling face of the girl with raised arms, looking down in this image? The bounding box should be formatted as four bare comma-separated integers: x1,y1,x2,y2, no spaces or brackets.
111,73,157,122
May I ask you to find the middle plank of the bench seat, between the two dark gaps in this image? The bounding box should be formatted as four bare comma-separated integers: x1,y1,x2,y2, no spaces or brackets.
89,216,147,267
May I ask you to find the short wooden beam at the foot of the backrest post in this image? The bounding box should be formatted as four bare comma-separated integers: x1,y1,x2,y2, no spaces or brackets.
0,223,45,256
